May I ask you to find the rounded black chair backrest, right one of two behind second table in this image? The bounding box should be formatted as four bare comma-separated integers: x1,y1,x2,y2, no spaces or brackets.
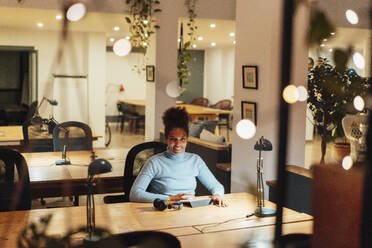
53,121,93,152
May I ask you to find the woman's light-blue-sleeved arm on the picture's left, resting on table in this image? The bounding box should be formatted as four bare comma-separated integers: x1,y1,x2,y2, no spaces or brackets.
129,162,168,202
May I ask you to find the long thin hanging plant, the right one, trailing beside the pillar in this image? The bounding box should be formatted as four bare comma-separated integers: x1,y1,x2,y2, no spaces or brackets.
177,0,198,87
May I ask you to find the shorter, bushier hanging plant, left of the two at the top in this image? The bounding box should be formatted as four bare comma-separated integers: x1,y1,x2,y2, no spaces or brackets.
125,0,161,55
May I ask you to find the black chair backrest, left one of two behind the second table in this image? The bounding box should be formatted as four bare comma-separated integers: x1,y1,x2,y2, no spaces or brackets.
22,119,53,152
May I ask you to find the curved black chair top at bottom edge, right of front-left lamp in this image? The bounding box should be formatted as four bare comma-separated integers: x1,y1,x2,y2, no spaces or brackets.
97,231,181,248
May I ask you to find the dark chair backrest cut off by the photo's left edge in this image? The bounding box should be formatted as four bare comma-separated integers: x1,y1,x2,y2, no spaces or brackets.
0,149,31,211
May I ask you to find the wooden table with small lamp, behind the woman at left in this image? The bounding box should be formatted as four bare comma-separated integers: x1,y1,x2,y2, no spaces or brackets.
22,149,129,199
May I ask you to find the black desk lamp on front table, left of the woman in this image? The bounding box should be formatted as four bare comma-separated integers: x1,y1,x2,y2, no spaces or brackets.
84,156,112,247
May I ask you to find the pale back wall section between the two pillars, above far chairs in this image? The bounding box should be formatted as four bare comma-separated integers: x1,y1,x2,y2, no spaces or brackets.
204,47,235,104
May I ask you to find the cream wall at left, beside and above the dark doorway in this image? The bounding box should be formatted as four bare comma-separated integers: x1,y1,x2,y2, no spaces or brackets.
0,28,106,146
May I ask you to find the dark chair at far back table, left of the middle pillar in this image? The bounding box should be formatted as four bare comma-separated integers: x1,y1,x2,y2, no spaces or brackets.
117,102,145,133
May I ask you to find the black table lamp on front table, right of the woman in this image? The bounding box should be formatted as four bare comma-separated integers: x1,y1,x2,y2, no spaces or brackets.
254,136,275,217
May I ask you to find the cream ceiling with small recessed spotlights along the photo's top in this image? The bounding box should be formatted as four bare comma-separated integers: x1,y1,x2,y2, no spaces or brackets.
0,0,369,49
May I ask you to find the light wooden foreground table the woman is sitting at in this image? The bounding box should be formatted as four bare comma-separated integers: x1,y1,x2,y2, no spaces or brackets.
0,193,312,248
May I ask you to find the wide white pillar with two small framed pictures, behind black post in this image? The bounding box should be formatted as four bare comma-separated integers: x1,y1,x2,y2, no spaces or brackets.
231,0,307,195
